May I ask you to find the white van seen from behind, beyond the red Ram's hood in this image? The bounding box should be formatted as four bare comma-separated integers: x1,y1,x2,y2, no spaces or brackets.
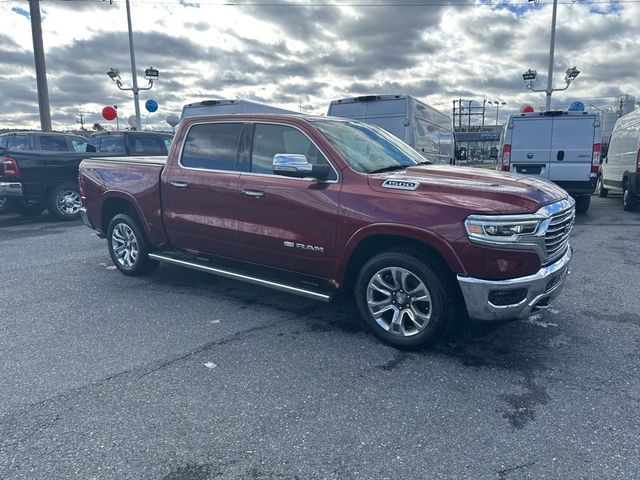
498,111,601,213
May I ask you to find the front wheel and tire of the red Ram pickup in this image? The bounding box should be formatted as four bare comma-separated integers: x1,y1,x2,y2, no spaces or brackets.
354,251,459,347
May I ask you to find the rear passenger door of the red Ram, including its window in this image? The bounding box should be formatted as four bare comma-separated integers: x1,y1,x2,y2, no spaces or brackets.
162,123,245,258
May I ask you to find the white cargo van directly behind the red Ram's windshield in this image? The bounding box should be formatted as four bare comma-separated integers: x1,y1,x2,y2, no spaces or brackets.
327,95,454,163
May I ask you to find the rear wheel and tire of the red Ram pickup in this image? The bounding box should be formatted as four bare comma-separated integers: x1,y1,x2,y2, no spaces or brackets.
107,213,158,277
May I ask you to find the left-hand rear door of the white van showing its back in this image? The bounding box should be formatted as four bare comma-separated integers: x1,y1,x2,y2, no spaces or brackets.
511,117,553,179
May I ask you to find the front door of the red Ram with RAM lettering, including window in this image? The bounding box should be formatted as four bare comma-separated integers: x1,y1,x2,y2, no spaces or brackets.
238,123,340,284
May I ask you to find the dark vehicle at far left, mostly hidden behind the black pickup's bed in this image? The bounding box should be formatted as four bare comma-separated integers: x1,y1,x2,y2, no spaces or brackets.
0,132,87,214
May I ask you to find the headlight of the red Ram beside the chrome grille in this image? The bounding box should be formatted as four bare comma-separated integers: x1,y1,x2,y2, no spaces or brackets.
464,215,540,243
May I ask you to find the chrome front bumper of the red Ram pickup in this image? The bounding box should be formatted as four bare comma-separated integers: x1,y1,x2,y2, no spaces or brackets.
458,247,573,320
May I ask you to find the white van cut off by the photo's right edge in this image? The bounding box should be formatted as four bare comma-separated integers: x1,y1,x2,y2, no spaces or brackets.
598,110,640,211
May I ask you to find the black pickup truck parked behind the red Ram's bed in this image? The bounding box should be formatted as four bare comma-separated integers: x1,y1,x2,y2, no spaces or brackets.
0,131,172,220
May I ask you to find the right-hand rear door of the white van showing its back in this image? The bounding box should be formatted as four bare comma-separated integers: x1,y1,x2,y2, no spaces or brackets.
548,115,599,182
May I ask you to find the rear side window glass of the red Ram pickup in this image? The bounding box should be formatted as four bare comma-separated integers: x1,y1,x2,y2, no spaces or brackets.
181,123,242,170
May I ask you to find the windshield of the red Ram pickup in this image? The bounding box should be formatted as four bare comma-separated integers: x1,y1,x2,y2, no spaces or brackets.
314,120,430,173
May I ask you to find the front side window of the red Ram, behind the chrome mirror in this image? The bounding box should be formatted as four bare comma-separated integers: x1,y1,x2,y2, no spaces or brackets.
251,123,336,180
